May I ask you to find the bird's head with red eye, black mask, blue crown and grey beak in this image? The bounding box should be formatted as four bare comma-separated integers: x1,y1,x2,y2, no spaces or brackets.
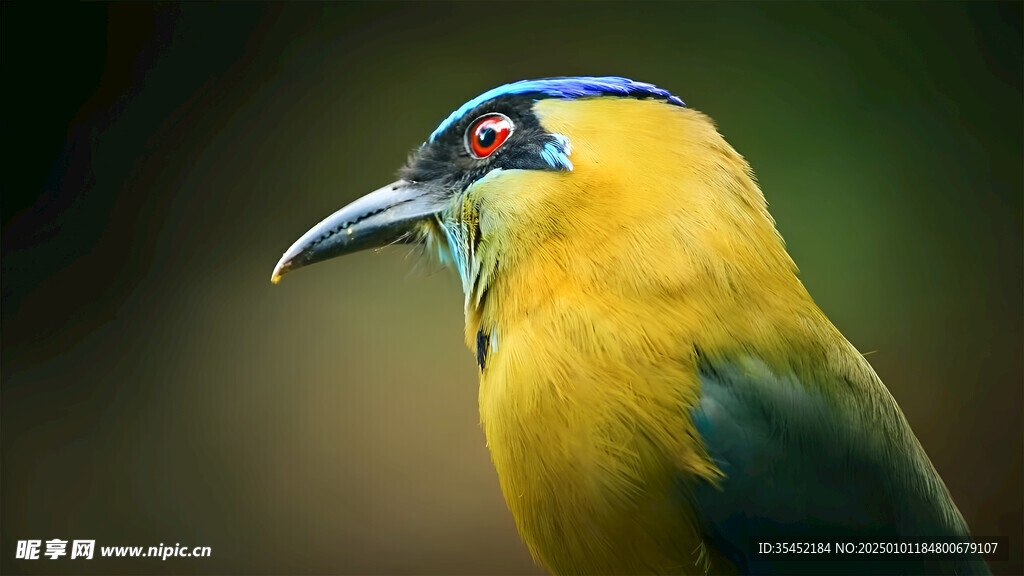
272,77,794,336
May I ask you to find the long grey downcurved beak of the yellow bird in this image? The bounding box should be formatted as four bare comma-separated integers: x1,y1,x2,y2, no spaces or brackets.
270,180,444,284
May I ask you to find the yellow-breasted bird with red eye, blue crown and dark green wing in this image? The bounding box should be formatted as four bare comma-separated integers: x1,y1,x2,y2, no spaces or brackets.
271,76,989,575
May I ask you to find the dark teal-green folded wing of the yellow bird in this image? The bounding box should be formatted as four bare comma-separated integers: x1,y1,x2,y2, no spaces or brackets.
691,357,990,574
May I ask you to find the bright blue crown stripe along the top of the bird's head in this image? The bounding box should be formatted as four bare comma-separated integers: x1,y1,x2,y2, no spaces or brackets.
430,76,686,141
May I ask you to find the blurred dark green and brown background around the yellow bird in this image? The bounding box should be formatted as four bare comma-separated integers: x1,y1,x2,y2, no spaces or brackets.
0,2,1024,574
